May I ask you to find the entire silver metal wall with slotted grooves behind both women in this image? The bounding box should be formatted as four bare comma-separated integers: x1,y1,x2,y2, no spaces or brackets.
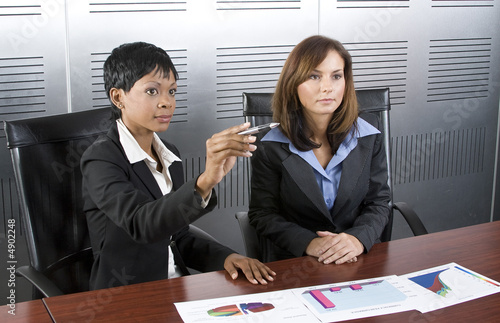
0,0,500,303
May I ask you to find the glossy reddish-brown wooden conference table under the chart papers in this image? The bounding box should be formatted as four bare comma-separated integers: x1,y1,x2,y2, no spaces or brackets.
0,221,500,323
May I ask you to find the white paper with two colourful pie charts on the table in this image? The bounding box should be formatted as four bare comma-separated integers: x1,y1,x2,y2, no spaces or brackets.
174,290,319,323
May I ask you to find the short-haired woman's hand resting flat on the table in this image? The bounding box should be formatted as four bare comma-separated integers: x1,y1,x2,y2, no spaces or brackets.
224,253,276,285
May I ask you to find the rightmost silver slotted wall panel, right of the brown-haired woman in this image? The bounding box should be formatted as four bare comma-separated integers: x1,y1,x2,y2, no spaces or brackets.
319,0,500,237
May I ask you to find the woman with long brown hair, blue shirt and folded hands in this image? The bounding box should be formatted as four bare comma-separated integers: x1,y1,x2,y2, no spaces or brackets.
249,36,390,264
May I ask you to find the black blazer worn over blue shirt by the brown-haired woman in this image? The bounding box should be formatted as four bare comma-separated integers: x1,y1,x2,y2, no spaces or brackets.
249,115,390,262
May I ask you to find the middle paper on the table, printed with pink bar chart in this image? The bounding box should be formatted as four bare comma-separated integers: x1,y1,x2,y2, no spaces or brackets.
293,276,419,322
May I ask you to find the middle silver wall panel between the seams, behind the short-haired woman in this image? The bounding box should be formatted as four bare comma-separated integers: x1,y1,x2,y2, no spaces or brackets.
62,1,318,258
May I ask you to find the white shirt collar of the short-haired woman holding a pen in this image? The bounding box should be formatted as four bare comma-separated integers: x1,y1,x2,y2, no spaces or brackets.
116,119,181,165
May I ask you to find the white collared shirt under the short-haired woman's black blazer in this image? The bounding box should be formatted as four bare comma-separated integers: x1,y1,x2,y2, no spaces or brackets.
116,119,184,278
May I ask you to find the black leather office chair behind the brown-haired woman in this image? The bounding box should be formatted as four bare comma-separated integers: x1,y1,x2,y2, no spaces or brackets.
236,89,427,259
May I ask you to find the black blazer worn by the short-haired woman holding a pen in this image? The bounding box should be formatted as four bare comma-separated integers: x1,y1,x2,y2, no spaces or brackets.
81,123,234,289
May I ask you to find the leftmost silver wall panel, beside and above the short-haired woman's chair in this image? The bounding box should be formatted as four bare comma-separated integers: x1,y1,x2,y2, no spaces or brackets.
0,0,69,304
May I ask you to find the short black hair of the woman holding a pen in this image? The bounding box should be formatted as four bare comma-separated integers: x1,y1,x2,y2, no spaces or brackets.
104,42,179,119
